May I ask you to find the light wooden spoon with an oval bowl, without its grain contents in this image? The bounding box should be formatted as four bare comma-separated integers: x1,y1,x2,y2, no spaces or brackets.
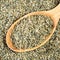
6,4,60,52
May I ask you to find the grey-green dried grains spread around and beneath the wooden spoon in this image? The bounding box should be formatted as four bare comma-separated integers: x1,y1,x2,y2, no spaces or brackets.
0,0,60,60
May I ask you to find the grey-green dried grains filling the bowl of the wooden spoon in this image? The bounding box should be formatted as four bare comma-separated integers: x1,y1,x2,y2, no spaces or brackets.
12,15,53,49
